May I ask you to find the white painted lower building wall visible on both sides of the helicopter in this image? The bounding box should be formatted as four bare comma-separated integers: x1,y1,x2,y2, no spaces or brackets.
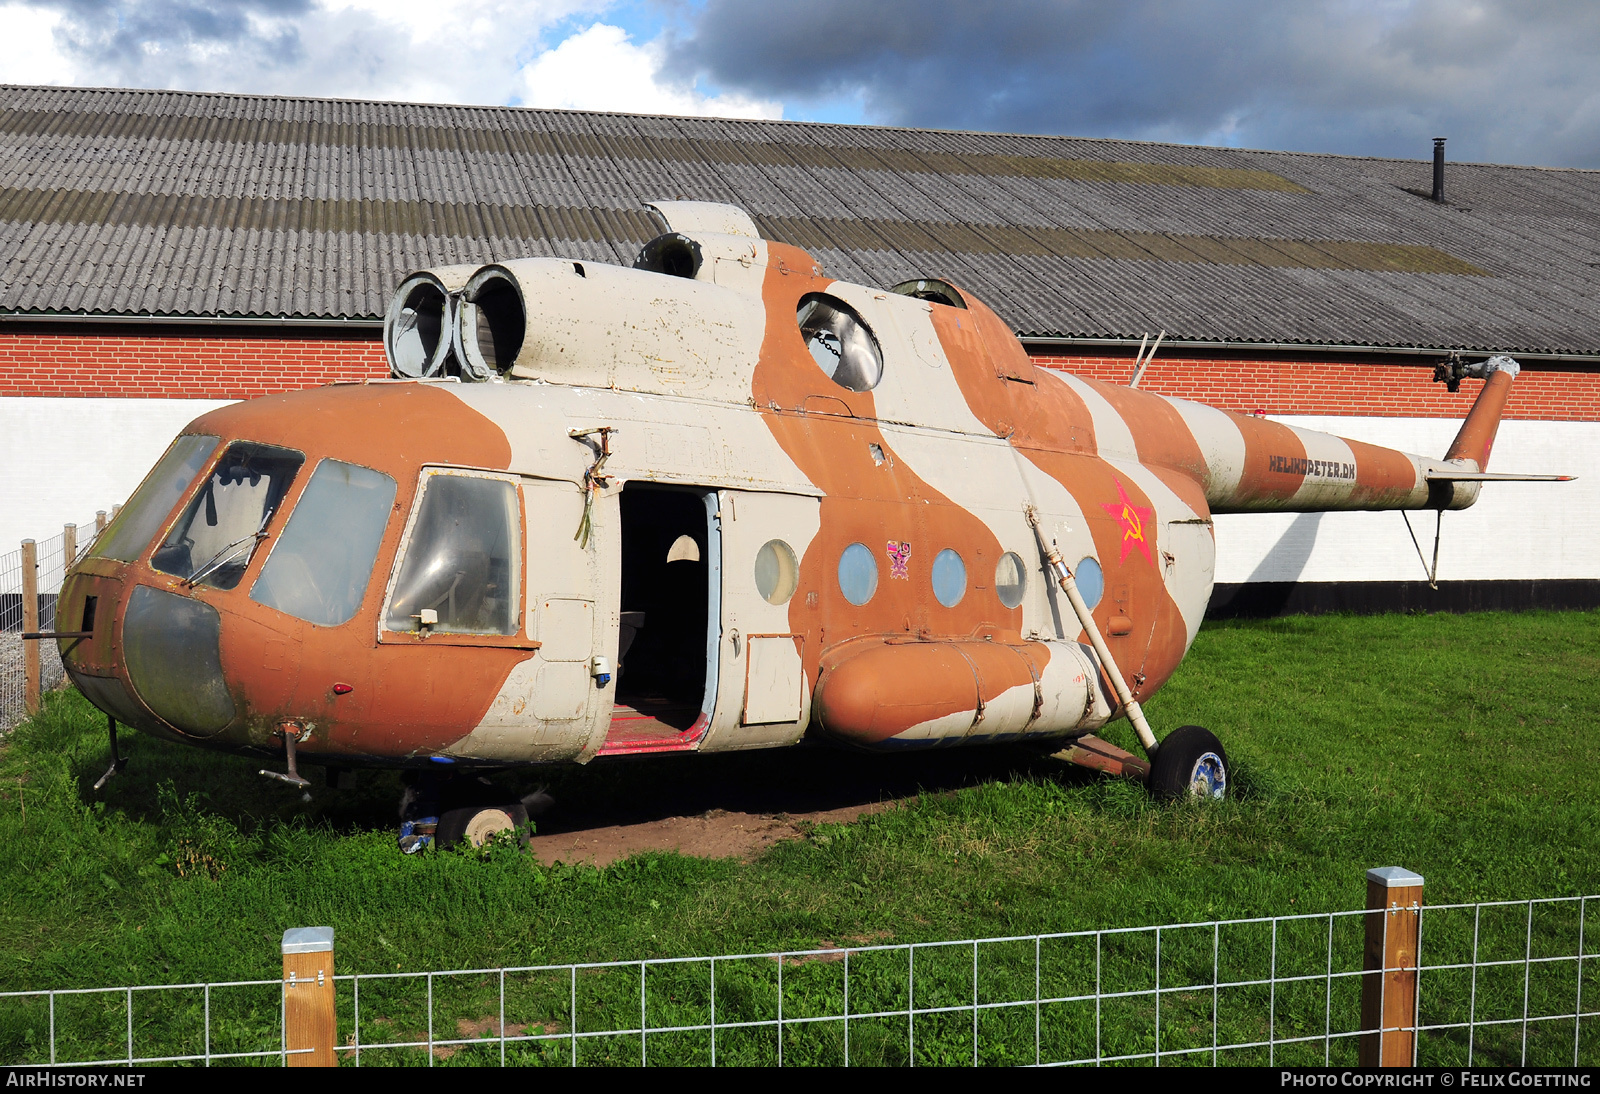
0,398,1600,592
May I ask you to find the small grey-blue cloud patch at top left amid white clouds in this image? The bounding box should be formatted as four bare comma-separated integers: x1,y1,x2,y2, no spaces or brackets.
37,0,312,79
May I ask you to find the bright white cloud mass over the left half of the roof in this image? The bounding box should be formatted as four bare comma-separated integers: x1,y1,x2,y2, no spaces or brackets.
0,0,782,118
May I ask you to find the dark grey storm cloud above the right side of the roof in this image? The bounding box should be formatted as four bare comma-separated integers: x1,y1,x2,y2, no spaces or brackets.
669,0,1600,166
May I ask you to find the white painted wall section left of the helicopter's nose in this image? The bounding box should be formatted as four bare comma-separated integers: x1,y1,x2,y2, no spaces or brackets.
0,398,227,569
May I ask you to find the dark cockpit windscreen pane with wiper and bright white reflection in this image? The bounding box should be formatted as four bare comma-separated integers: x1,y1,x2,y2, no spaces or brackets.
150,441,306,589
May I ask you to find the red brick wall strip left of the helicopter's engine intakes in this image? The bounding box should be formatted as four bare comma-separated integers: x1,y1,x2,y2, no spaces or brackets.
0,325,389,398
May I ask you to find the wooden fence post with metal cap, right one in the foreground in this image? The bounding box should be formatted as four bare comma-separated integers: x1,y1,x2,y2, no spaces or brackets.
1358,867,1422,1067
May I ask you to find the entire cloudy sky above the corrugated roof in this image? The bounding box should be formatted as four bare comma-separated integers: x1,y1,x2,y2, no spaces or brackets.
0,0,1600,168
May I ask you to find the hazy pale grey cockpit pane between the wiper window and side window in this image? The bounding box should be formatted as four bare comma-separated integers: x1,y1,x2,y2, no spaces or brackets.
250,459,395,627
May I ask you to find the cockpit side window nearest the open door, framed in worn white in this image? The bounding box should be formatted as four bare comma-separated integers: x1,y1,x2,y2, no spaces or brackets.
384,470,522,635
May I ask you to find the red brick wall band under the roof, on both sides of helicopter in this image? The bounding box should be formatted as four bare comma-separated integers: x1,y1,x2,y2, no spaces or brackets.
0,325,1600,422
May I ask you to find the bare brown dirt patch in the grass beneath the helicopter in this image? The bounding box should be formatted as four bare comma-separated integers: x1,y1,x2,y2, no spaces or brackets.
533,801,894,865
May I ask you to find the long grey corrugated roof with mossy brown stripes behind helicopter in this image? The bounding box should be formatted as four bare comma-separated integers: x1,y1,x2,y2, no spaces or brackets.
0,86,1600,353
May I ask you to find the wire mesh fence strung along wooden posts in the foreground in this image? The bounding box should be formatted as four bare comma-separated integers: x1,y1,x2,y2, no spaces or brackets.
0,897,1600,1067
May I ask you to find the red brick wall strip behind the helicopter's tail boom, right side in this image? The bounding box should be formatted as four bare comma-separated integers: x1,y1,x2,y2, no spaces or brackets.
1034,353,1600,422
